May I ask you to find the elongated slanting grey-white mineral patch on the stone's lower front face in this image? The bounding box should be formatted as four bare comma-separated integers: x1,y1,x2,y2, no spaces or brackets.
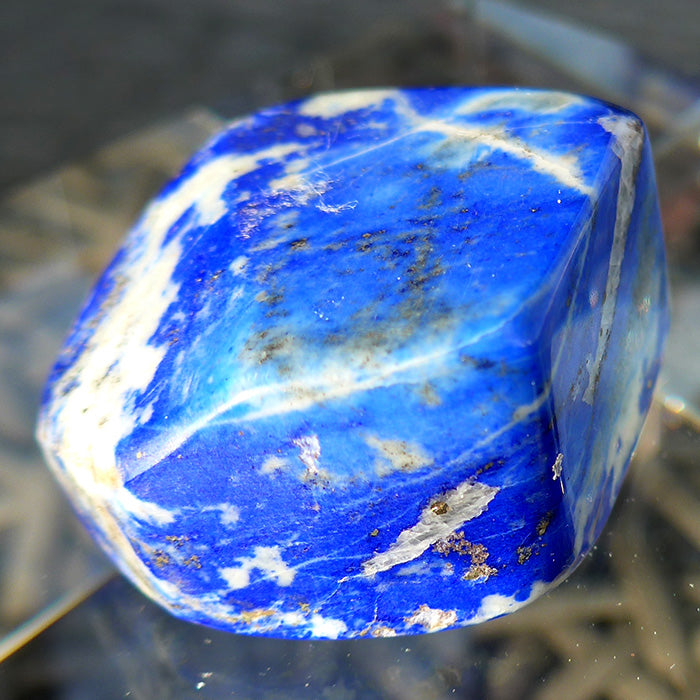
362,481,500,576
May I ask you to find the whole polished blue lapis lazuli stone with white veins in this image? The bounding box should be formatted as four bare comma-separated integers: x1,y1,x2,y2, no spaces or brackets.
38,88,668,638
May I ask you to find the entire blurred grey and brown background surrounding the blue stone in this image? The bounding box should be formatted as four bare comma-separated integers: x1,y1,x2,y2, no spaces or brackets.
0,0,700,700
